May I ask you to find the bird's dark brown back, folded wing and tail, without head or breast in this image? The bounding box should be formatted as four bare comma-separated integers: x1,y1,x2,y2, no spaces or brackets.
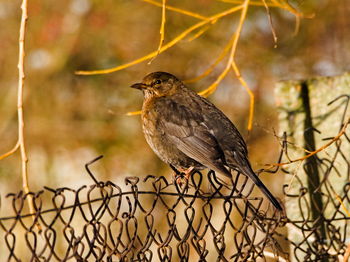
156,93,282,210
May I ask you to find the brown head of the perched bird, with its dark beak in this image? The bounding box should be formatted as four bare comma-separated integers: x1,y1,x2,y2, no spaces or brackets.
131,72,183,97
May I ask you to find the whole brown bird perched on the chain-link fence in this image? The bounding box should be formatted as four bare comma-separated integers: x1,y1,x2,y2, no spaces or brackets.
131,72,282,210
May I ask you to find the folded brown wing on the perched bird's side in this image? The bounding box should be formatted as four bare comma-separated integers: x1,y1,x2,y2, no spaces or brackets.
155,97,230,176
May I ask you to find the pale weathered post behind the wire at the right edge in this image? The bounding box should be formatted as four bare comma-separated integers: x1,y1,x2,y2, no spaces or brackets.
275,74,350,261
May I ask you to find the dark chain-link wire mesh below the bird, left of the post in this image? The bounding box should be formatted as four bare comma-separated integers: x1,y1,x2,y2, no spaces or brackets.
0,168,285,261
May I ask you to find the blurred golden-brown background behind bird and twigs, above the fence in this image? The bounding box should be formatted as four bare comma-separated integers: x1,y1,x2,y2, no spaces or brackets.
0,0,350,199
